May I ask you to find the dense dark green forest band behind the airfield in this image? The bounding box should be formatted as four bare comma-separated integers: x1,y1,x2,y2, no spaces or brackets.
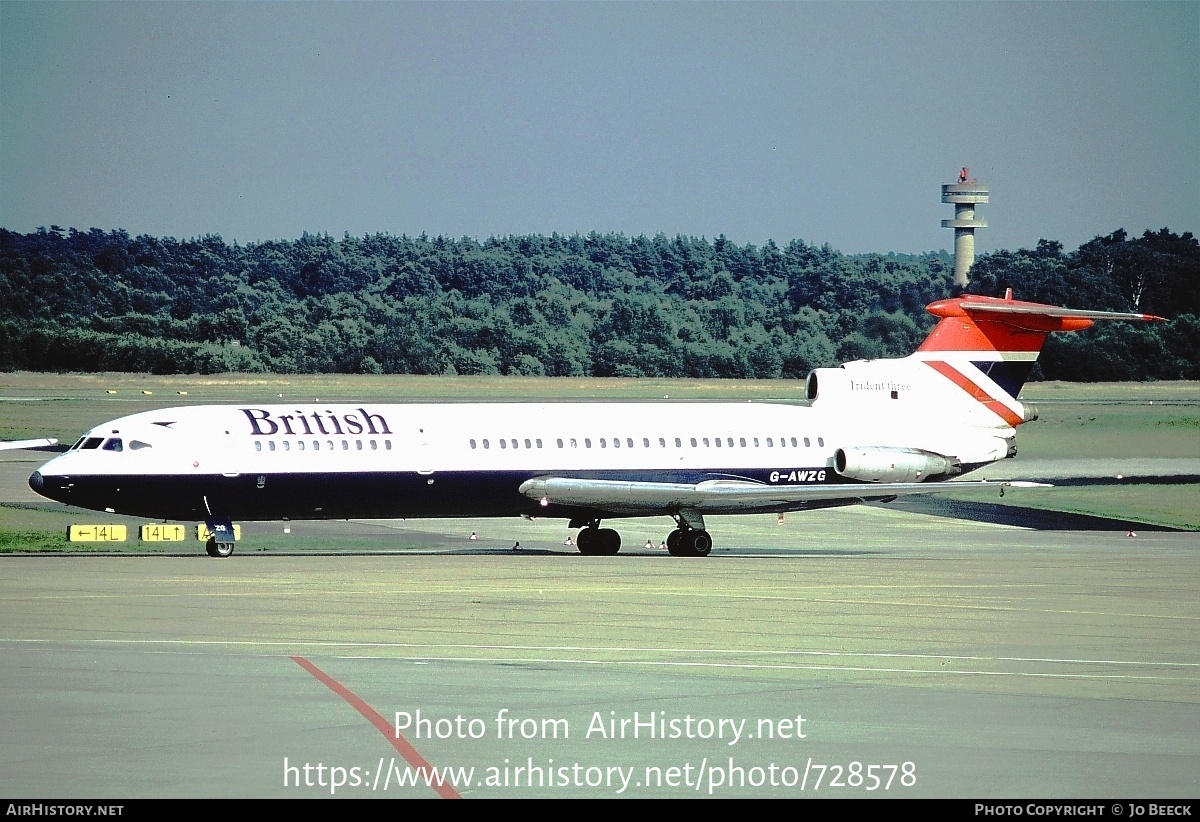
0,226,1200,380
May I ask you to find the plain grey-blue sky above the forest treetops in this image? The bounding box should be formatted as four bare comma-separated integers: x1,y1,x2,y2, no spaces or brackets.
0,1,1200,253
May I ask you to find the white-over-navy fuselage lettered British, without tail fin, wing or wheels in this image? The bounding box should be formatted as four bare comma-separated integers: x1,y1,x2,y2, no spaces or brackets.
31,402,1006,518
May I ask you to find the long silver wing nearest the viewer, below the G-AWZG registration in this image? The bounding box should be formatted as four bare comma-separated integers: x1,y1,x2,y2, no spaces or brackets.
521,476,1050,516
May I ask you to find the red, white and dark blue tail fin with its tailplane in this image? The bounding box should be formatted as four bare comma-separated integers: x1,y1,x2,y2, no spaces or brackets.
911,289,1163,426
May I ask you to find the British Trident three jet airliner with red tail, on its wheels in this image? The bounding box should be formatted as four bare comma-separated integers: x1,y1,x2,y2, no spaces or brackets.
29,289,1162,557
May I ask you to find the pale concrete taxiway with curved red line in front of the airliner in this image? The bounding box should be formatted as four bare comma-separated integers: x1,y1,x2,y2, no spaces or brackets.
0,508,1200,798
